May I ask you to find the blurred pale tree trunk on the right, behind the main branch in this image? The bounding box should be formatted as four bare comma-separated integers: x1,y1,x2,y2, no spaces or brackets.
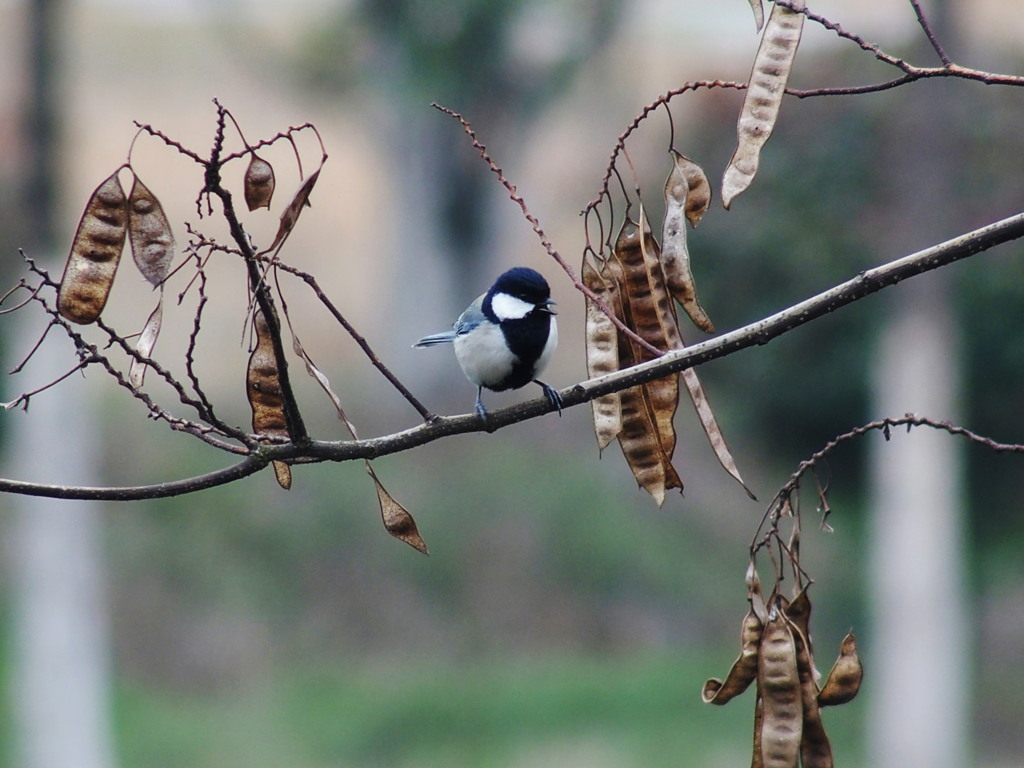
867,0,972,768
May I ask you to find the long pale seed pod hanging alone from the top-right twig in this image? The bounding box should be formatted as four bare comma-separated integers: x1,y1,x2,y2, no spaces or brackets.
722,0,804,208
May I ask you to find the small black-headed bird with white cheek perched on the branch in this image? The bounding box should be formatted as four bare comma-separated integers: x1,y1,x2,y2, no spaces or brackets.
413,266,562,421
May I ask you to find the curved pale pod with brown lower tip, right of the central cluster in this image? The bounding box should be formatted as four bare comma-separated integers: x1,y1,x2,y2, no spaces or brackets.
660,150,715,333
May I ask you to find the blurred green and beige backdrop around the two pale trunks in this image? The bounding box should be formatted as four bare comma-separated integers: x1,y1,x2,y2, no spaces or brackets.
0,0,1024,768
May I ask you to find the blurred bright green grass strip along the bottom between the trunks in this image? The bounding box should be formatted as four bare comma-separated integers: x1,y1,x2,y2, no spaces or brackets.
108,653,861,768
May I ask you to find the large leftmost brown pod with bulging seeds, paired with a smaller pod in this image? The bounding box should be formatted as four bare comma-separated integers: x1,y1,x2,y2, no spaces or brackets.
57,168,128,325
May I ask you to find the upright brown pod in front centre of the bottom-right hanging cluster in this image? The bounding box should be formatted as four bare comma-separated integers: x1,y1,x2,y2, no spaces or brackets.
758,608,804,768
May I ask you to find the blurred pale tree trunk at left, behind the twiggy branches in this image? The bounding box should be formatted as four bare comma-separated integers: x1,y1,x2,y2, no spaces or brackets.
6,0,114,768
